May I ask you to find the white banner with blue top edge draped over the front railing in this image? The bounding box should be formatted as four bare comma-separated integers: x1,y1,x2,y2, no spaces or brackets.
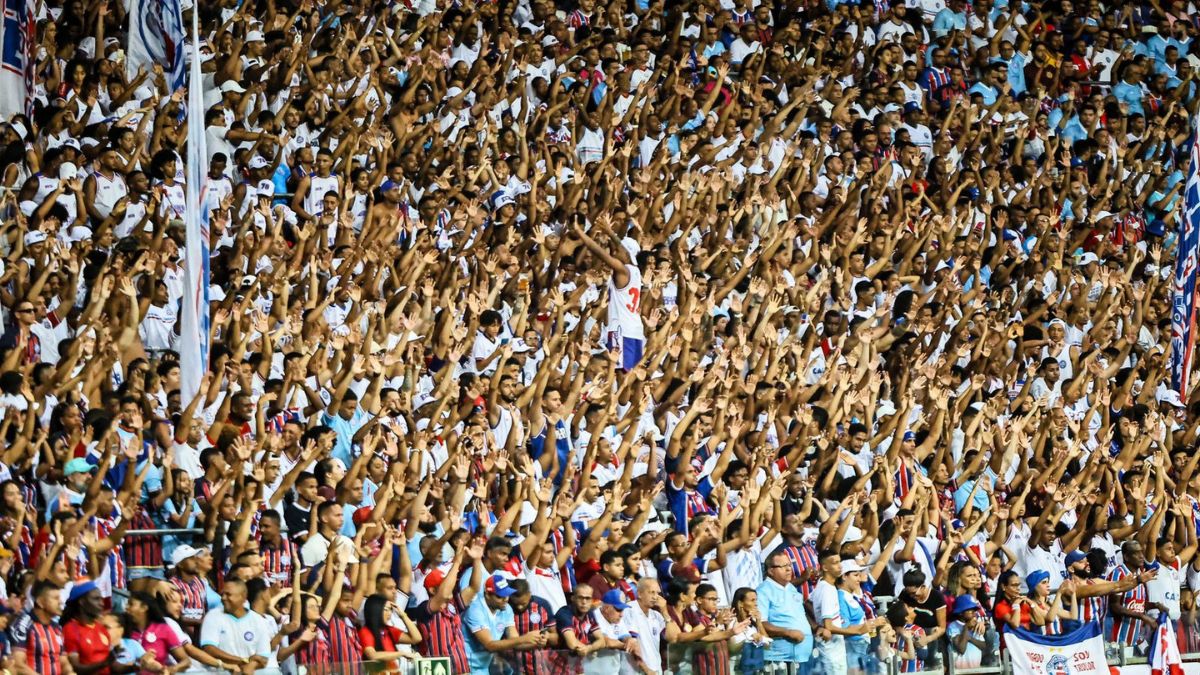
1004,621,1109,675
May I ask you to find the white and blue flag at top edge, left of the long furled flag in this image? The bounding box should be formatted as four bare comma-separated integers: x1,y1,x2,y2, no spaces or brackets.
126,0,184,91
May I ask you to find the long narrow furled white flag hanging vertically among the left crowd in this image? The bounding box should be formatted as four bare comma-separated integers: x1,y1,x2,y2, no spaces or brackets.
179,11,209,406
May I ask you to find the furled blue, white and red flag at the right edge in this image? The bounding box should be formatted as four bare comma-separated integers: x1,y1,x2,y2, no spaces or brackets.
1171,115,1200,391
